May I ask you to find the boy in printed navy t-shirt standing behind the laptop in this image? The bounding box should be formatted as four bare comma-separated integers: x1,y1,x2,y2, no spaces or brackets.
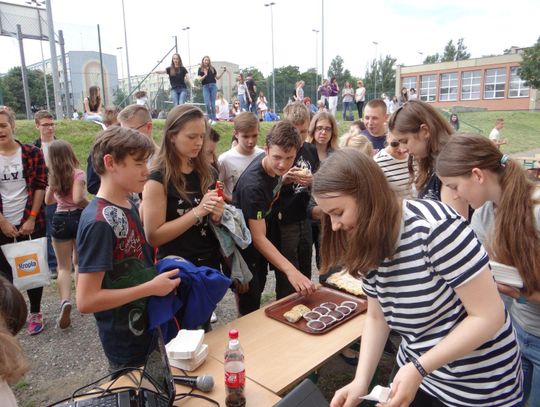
77,126,180,371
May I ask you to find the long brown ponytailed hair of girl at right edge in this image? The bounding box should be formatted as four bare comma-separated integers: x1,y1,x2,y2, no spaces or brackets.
436,133,540,295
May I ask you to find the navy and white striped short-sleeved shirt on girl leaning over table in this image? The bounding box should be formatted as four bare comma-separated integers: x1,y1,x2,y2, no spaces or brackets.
364,200,523,407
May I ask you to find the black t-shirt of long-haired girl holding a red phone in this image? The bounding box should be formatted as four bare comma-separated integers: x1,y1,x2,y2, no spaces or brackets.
149,171,219,264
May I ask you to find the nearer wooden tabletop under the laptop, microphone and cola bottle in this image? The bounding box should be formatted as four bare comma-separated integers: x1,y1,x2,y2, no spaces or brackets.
172,358,281,407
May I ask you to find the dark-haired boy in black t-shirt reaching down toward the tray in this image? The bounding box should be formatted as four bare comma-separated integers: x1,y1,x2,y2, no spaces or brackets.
233,120,315,315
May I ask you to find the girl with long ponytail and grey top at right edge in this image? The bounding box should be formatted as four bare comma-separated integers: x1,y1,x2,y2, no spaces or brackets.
437,134,540,406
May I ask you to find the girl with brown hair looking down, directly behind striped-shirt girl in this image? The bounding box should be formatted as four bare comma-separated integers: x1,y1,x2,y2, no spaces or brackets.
388,100,469,219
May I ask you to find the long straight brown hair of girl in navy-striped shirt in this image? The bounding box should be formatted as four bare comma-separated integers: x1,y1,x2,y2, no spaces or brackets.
312,148,401,277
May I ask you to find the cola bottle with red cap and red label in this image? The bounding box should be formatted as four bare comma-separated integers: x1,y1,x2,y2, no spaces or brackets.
225,329,246,407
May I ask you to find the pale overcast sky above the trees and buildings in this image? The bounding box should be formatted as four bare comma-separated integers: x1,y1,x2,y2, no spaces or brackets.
0,0,540,77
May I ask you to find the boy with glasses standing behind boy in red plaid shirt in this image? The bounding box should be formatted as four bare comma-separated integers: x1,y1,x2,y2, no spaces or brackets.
34,110,57,278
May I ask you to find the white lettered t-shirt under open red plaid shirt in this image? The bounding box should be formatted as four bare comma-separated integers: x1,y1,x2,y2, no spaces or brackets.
0,146,28,226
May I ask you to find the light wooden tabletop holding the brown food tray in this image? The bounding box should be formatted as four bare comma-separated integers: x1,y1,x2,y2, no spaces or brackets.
204,294,365,394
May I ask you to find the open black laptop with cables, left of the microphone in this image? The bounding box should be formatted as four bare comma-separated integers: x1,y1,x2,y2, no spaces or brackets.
54,327,176,407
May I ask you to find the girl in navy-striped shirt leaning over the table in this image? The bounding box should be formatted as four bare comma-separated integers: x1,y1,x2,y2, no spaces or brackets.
313,149,522,407
